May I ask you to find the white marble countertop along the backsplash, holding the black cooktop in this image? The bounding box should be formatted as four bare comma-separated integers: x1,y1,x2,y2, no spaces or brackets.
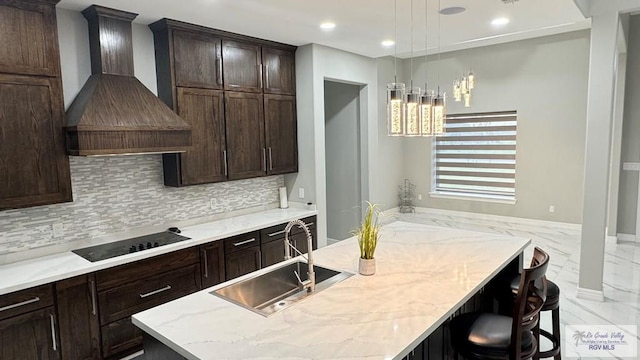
0,208,317,295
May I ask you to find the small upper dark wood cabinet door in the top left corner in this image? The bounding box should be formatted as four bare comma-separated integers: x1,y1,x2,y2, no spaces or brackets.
0,1,60,76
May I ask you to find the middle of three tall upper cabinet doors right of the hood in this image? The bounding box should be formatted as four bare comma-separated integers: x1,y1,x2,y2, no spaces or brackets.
224,92,267,180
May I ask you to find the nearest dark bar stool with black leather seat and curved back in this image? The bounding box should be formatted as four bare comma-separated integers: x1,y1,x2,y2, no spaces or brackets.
450,247,549,360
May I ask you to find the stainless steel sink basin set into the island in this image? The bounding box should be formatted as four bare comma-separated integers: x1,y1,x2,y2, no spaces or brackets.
211,261,353,316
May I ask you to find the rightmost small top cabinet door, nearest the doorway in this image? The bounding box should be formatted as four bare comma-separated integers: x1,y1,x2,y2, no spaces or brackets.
262,47,296,95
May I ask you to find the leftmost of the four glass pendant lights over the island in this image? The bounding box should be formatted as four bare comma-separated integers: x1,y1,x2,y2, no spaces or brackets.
387,0,405,136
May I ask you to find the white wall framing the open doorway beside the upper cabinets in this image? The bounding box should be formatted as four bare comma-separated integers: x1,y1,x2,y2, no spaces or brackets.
286,44,402,246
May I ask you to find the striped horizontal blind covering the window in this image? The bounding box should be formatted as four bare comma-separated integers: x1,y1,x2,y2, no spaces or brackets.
435,111,517,199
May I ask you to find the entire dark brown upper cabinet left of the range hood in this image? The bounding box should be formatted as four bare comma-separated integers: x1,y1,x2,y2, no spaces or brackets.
0,0,72,210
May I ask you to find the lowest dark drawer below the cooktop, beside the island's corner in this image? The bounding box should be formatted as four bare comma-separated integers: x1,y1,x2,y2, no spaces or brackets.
101,317,142,358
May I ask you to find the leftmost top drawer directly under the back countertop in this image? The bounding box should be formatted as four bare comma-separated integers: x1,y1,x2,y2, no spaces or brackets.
0,284,53,320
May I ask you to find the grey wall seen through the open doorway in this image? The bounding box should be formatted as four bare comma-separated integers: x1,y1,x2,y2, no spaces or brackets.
324,81,362,240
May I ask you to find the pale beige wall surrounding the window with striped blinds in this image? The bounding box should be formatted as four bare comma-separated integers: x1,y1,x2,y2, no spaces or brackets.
403,31,589,223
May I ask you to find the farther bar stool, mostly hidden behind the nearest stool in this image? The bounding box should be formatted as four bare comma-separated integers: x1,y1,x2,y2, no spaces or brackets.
510,276,562,360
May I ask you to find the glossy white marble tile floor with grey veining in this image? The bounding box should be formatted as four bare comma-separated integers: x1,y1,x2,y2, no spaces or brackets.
398,213,640,359
